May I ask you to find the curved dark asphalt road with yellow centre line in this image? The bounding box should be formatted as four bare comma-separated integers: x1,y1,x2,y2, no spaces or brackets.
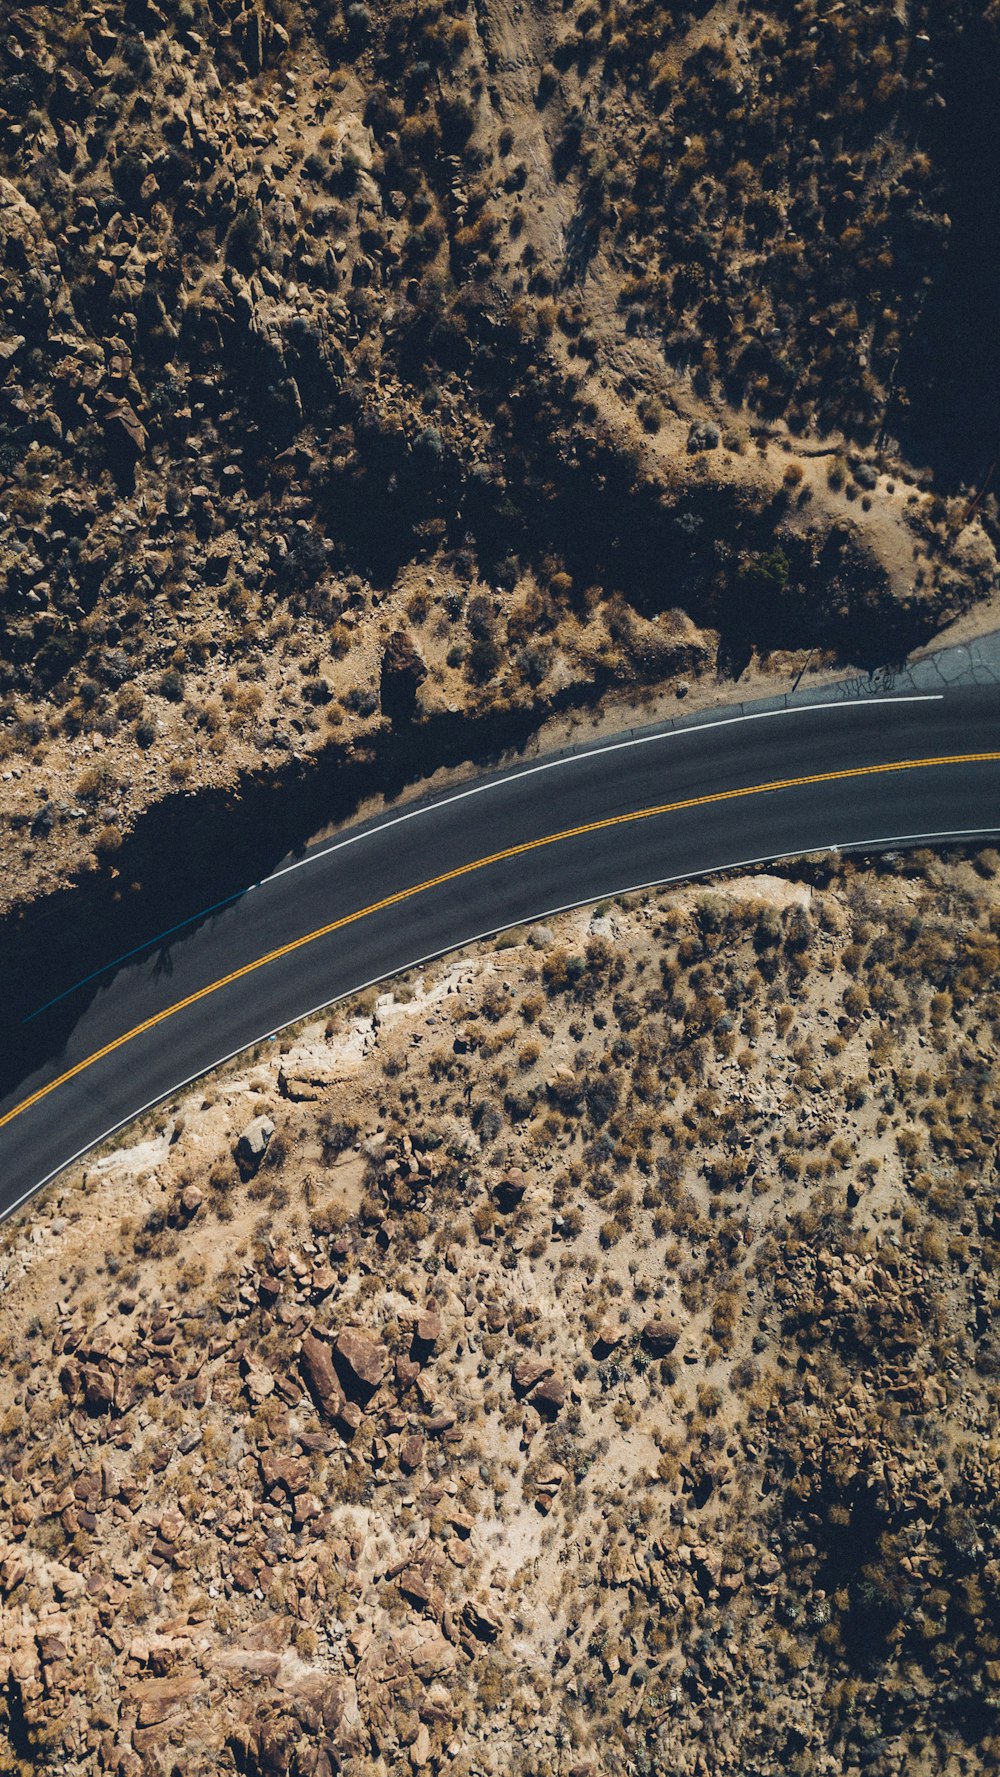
0,684,1000,1215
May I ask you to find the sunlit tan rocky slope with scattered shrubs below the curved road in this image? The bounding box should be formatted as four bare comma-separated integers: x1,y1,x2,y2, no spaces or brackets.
0,853,1000,1777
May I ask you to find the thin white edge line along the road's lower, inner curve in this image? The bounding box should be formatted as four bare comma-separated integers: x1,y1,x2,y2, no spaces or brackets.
0,813,1000,1223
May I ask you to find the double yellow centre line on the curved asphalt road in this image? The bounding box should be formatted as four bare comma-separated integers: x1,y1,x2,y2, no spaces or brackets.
0,752,1000,1128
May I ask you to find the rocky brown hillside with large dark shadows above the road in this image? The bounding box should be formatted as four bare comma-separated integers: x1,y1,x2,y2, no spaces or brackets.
0,0,1000,901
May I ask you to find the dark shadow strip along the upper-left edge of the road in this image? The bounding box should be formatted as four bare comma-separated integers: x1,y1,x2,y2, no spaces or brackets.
0,682,618,1095
